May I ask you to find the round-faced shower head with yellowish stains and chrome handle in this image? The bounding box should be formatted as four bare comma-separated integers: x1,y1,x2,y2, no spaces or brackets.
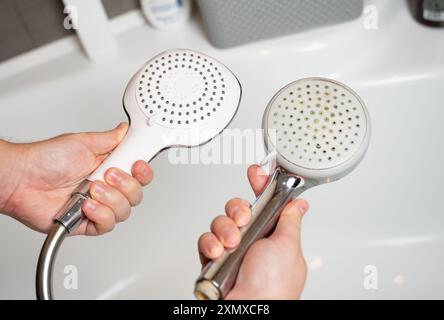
195,78,371,299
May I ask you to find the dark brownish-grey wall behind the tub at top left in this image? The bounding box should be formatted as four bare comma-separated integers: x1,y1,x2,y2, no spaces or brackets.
0,0,139,62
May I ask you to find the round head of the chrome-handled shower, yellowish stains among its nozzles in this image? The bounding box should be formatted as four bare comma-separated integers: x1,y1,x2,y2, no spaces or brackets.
262,78,370,183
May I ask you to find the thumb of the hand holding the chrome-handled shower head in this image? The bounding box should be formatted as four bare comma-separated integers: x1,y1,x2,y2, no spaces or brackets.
270,199,308,246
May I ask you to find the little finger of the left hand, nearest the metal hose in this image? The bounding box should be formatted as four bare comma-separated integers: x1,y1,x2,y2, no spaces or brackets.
82,199,116,235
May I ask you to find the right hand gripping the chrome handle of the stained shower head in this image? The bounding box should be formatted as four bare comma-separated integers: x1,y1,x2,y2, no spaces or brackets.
198,165,308,300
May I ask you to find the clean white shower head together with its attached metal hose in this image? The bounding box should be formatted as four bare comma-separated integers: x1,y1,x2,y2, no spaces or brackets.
36,49,241,299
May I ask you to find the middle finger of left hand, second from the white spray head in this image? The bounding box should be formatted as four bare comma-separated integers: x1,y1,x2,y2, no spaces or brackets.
105,168,143,206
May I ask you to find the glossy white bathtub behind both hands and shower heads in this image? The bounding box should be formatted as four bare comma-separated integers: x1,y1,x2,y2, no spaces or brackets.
0,1,444,299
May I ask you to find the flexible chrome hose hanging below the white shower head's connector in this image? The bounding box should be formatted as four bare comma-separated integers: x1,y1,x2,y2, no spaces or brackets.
35,222,68,300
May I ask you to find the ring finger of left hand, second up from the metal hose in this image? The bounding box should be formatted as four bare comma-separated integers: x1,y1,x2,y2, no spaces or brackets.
90,181,131,222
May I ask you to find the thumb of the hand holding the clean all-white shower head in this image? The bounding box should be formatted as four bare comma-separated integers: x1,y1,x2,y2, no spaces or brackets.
85,122,128,155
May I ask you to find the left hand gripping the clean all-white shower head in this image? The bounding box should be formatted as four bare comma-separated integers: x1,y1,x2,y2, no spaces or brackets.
0,123,153,235
